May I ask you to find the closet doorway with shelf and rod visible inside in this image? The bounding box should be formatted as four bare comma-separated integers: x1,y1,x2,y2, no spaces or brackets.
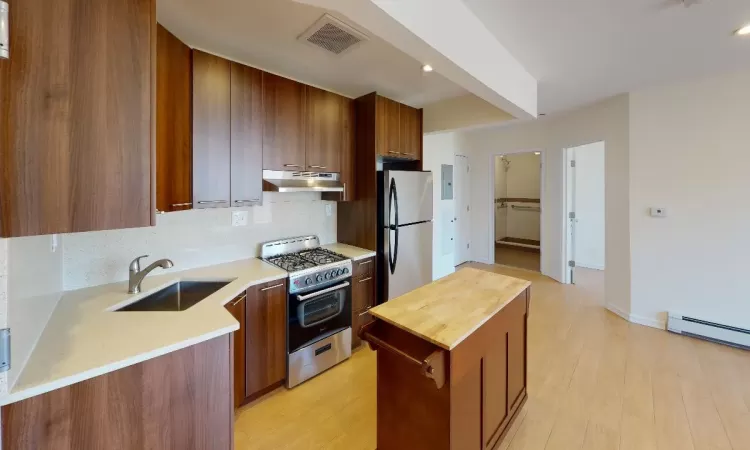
494,151,542,272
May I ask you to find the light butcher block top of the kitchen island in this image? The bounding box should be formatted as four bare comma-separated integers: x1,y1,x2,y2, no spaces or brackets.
370,268,531,350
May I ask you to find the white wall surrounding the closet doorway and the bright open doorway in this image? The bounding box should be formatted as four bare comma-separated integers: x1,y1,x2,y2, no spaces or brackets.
462,95,630,311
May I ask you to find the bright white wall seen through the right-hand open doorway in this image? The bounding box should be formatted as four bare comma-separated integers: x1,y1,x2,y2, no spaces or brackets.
571,142,606,270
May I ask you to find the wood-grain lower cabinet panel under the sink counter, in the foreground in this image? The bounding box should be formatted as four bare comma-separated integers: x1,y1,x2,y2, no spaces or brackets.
2,335,234,450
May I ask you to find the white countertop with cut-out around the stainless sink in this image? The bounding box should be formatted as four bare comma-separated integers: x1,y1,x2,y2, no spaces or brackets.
0,258,287,406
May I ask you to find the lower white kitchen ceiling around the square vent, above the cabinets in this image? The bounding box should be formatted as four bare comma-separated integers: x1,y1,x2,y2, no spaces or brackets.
157,0,466,107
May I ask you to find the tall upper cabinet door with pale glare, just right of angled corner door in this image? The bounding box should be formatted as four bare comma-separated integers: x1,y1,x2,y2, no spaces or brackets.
193,50,231,208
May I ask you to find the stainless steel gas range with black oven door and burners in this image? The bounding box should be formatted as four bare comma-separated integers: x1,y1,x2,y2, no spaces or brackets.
261,236,352,388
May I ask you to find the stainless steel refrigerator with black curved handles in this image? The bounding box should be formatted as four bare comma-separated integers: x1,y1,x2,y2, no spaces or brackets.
378,170,432,303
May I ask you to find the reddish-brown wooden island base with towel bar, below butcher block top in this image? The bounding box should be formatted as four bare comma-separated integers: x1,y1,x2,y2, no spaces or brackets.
360,289,530,450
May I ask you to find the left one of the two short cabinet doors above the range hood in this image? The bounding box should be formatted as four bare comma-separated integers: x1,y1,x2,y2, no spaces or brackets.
263,73,306,170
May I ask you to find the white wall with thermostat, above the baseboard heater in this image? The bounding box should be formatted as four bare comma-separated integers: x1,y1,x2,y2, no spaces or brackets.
628,71,750,328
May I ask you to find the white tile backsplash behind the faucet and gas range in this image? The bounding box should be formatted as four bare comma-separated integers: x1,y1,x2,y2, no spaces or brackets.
61,192,336,290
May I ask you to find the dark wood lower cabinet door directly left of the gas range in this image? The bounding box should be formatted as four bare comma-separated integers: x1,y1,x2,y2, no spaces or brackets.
245,280,287,396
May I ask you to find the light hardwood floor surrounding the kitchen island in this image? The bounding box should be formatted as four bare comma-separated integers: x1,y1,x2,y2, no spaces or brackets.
235,264,750,450
